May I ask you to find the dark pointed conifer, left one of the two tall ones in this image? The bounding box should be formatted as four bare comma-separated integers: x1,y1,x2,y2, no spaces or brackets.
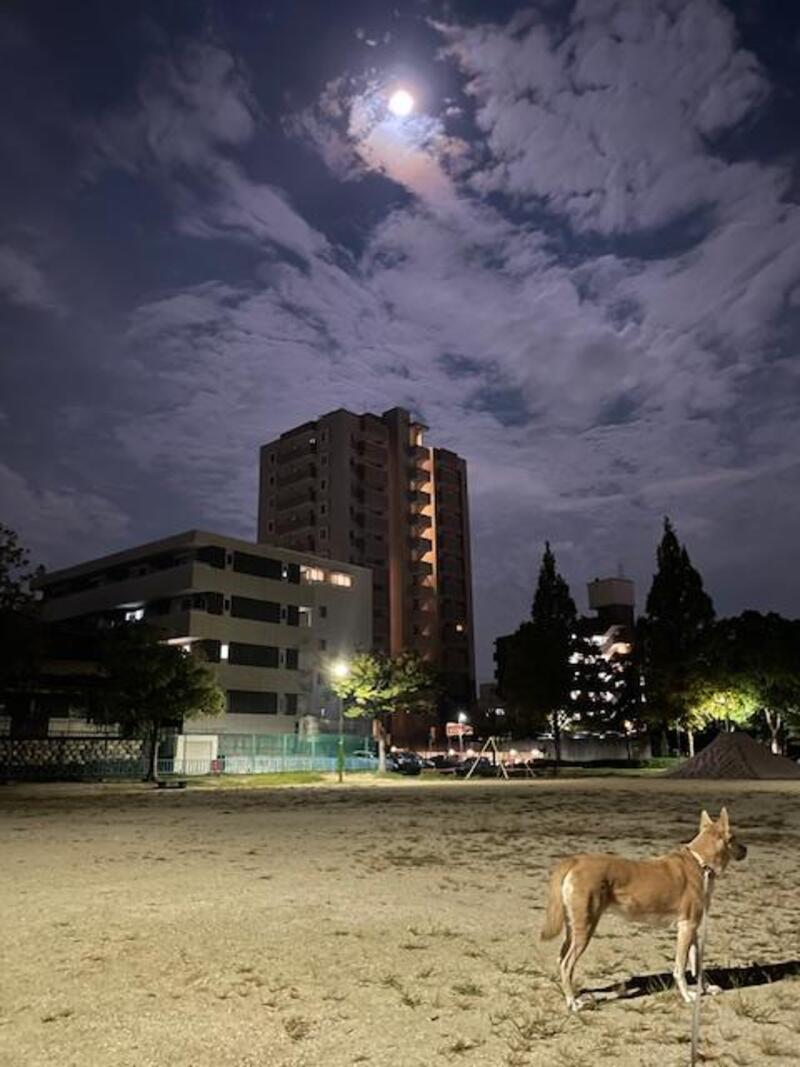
498,541,577,773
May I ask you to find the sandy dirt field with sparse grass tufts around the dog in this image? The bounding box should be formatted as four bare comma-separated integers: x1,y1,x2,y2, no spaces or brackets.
0,779,800,1067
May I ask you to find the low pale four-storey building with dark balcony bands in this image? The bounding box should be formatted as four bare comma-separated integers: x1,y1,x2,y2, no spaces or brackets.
36,530,372,734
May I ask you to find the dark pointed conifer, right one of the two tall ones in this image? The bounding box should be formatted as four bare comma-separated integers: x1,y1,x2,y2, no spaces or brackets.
639,519,714,751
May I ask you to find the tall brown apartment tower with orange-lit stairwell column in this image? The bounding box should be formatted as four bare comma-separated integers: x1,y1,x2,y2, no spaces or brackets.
258,408,475,707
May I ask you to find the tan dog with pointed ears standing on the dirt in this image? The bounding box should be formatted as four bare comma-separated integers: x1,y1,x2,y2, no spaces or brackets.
541,808,747,1012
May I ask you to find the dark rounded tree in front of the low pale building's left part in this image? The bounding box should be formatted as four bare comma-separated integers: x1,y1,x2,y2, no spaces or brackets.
90,623,225,780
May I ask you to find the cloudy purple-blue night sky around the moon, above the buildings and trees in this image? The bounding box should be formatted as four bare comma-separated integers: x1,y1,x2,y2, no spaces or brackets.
0,0,800,679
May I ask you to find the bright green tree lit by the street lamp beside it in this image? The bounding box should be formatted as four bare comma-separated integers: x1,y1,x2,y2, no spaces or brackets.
331,652,436,770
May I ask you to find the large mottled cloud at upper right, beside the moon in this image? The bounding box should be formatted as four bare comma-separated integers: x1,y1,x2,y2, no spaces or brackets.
439,0,768,234
